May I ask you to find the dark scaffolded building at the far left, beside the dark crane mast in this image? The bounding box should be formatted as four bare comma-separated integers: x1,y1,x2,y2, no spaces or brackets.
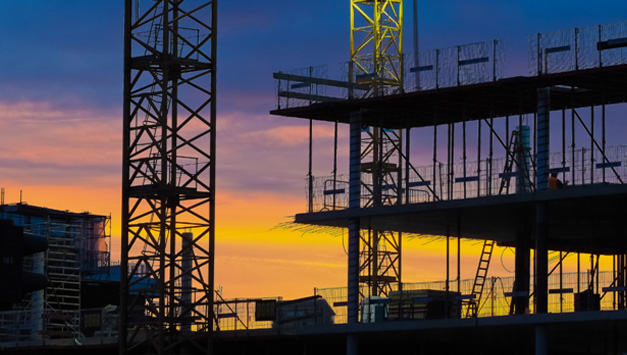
0,203,112,349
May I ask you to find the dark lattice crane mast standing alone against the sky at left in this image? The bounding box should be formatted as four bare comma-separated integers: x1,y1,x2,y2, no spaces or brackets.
120,0,217,354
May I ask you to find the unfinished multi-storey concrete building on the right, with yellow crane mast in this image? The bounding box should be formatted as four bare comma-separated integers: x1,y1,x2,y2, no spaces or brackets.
272,1,627,354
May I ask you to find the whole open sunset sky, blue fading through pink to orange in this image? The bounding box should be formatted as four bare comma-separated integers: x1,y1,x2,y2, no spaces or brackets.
0,0,627,298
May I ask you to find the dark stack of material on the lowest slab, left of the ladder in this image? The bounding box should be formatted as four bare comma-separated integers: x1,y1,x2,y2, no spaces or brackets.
388,290,461,319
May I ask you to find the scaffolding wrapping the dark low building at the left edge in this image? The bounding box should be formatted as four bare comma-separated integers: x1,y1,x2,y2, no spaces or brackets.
0,203,111,344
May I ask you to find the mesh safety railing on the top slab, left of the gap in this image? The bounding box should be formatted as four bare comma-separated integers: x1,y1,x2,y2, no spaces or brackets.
274,40,505,109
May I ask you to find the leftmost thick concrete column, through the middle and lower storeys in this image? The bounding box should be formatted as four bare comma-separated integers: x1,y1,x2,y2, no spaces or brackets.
347,112,361,324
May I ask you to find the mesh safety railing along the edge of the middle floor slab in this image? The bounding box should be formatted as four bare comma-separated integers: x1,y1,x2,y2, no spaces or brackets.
306,145,627,212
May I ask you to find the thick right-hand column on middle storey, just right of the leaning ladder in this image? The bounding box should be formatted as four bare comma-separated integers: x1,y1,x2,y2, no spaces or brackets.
536,87,551,191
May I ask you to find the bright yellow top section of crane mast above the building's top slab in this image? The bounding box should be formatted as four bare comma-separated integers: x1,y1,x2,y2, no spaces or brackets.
350,0,403,97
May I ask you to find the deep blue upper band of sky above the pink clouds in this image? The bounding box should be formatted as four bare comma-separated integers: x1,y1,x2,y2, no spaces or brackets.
0,0,627,112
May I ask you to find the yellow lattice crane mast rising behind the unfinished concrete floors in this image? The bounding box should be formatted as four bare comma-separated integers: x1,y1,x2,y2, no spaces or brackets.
349,0,403,297
